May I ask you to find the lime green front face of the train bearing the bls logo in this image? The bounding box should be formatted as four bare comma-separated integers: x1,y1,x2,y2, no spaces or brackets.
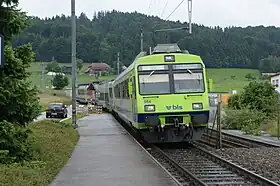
136,54,209,143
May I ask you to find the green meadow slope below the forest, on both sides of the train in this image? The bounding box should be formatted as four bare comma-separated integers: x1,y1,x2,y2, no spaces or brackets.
28,62,260,92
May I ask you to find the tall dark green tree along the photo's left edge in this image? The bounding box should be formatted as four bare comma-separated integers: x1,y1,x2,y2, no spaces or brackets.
0,0,40,163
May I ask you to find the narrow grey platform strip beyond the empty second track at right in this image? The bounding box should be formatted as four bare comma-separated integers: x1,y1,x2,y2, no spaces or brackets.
208,123,280,147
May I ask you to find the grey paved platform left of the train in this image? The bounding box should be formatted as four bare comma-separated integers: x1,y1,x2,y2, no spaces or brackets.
50,114,176,186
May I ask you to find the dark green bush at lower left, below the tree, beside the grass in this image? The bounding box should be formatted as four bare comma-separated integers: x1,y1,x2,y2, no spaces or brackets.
0,121,32,164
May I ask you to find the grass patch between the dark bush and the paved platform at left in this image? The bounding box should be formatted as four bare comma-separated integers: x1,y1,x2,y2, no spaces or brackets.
0,120,79,186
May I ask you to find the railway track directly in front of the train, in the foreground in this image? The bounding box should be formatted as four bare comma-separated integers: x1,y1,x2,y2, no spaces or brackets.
149,144,279,186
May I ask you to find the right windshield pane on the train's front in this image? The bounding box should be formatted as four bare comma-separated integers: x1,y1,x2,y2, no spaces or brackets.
173,71,204,93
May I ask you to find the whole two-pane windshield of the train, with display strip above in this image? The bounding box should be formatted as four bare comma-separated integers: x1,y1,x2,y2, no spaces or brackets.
138,63,205,95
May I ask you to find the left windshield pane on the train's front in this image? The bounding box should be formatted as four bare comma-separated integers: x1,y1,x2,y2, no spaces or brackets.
139,71,170,94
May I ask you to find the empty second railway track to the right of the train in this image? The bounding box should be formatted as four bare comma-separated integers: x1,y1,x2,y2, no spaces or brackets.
199,128,280,148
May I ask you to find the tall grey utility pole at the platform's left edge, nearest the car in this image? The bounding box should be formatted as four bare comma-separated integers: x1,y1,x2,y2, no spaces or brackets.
71,0,78,128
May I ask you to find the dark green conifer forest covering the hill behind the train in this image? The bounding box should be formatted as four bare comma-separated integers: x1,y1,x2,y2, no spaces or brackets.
13,10,280,72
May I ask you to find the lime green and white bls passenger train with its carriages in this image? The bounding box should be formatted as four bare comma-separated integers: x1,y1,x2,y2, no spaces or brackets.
95,44,212,143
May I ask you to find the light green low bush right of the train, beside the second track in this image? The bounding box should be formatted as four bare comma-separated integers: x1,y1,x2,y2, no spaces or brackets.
223,108,267,135
